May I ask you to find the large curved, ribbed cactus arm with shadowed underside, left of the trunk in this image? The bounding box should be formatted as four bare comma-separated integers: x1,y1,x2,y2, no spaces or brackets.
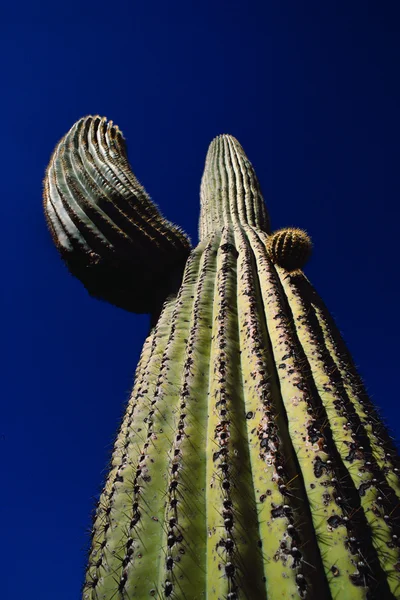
44,116,190,312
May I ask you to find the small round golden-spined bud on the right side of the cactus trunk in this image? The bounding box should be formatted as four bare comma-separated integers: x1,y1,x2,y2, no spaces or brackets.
267,227,312,271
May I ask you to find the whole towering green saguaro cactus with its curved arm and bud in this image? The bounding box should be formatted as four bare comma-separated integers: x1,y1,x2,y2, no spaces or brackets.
44,117,400,600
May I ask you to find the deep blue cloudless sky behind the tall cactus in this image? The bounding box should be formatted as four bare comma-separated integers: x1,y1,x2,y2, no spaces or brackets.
0,0,400,600
